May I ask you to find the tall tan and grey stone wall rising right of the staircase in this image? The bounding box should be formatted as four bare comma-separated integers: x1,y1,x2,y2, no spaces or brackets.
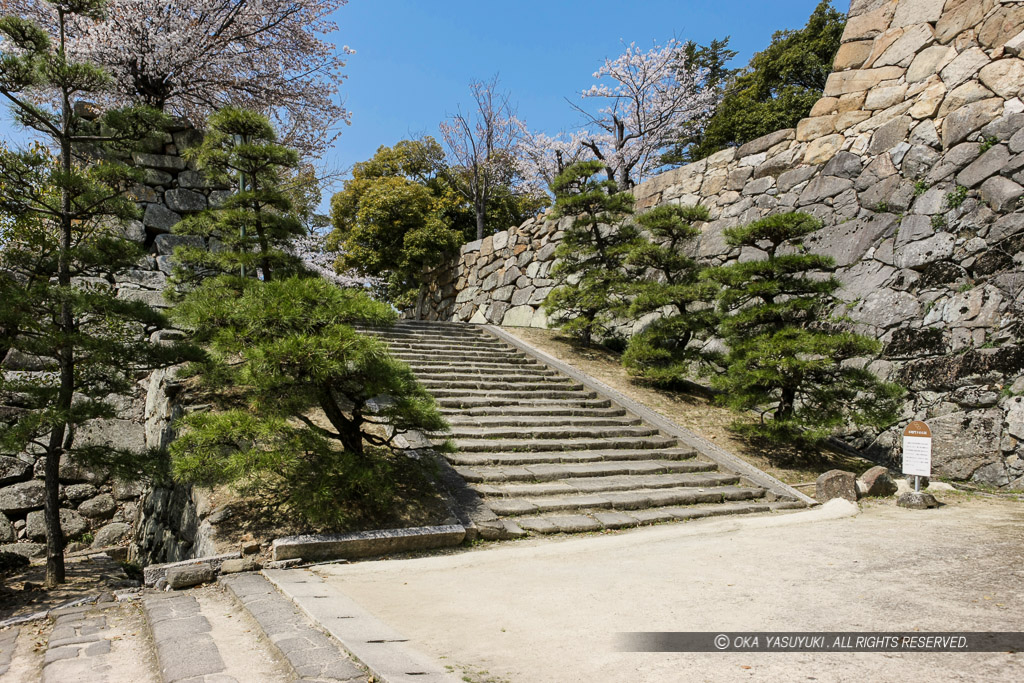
414,0,1024,489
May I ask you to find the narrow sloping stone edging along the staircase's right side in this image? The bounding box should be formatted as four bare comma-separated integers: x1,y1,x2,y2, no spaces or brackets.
481,325,817,505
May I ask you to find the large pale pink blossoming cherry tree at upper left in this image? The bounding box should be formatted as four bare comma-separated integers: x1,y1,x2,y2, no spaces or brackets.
0,0,352,153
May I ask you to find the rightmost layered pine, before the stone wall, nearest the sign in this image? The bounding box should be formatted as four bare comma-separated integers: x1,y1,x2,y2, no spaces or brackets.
706,213,902,443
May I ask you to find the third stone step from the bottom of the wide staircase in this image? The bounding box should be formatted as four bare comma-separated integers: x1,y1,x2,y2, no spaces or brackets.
473,472,739,498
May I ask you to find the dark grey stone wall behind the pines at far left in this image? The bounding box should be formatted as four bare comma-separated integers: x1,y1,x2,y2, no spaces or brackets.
0,124,218,563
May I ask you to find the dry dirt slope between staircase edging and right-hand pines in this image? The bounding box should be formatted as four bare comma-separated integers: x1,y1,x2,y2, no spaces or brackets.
502,328,888,496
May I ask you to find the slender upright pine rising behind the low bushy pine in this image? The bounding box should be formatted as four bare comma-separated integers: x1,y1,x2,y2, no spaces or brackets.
173,108,306,283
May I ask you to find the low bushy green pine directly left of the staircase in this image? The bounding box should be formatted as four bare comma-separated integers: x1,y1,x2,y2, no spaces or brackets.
171,275,446,527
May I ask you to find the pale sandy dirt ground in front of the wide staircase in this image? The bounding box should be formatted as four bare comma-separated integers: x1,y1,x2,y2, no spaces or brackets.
317,494,1024,683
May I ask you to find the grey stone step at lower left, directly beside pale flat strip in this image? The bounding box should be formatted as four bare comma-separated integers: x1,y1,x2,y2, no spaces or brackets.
217,573,369,683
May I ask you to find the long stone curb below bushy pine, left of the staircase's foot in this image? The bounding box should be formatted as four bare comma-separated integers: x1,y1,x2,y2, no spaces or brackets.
271,524,466,561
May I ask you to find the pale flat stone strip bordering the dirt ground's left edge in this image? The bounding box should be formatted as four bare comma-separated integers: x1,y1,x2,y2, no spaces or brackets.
263,569,460,683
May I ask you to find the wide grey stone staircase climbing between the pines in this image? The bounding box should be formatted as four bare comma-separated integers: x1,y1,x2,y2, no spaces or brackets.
362,321,804,538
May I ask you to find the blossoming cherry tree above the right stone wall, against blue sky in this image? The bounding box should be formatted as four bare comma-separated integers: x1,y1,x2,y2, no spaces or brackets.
570,40,718,189
